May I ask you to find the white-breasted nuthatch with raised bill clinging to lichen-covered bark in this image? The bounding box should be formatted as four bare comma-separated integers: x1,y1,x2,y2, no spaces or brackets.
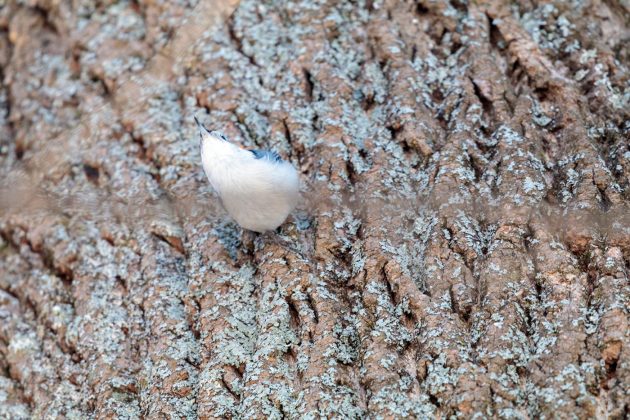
195,117,300,233
